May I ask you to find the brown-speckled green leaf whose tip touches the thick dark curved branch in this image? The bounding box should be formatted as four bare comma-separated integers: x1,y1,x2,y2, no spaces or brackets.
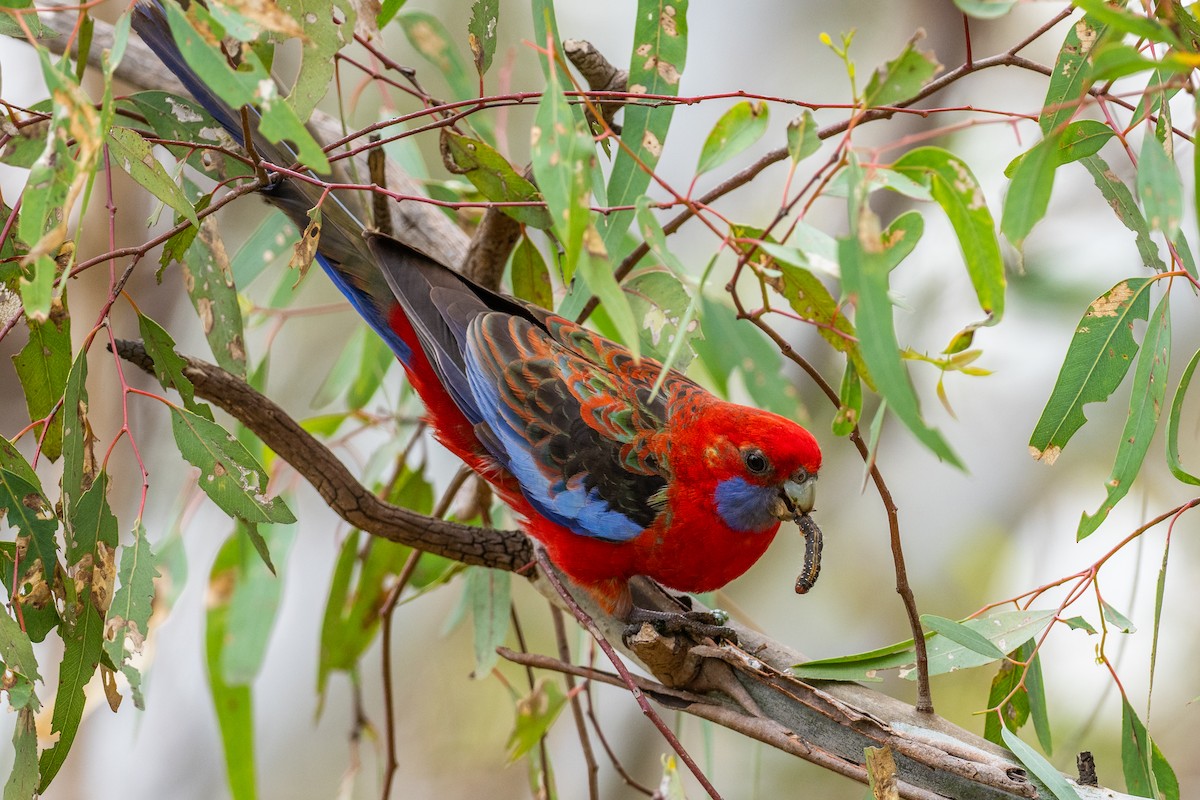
184,217,246,378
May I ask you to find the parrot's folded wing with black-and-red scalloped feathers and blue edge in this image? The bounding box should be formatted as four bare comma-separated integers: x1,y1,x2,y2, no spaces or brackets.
467,313,685,541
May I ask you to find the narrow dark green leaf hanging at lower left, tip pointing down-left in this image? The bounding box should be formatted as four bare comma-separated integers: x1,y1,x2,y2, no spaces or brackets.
38,602,104,793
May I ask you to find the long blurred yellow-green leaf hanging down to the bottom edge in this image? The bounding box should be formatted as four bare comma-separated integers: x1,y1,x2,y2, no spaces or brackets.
204,533,258,800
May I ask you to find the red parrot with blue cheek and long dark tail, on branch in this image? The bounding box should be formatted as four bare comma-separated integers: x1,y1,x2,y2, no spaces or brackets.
133,0,821,620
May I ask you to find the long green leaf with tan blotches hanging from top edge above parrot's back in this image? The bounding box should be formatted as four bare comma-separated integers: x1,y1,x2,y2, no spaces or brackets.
604,0,688,258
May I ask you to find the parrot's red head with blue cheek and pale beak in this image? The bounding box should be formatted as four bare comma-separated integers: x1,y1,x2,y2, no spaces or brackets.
677,403,821,533
